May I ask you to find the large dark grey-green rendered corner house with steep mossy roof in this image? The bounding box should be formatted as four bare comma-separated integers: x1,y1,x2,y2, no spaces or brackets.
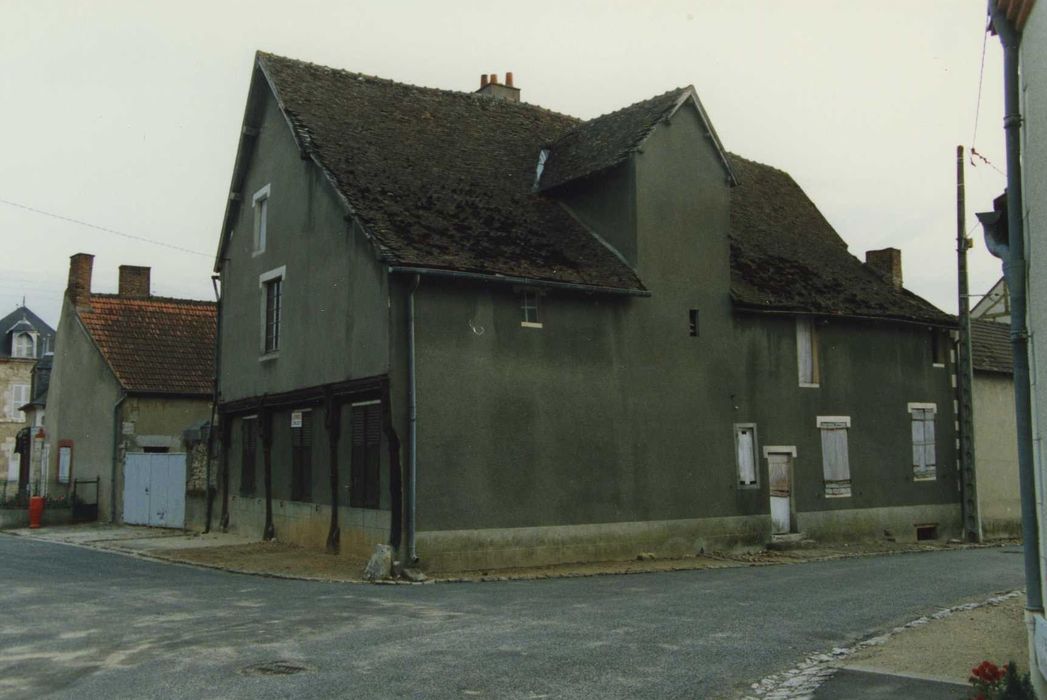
216,53,960,569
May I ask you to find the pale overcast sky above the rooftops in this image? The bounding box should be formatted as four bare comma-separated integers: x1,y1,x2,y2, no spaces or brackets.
0,0,1005,325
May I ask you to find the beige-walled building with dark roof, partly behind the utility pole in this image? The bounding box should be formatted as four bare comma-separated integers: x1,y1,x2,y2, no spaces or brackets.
971,319,1022,538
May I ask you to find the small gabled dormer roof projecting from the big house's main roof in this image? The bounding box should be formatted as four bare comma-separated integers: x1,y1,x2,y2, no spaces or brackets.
537,87,734,190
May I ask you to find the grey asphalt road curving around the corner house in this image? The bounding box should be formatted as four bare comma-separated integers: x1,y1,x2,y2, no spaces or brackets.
0,537,1023,700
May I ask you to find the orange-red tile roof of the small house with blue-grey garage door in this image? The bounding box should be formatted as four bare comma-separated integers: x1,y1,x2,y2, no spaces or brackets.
79,294,215,397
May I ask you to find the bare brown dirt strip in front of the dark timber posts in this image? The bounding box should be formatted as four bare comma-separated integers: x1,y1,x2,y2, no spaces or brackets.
154,542,367,581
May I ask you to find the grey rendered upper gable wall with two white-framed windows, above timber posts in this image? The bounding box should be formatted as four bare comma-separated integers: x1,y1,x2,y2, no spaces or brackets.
221,83,388,402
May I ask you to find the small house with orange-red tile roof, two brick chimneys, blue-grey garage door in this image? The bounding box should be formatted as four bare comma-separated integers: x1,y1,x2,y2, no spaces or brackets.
44,253,215,526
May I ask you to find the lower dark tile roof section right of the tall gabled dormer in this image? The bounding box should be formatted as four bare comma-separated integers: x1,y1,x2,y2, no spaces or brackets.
731,155,956,325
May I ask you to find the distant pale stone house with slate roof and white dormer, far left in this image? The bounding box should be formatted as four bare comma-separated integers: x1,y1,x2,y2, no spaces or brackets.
0,304,54,498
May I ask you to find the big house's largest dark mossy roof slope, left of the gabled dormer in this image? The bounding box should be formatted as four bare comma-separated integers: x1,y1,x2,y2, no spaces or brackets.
259,53,643,290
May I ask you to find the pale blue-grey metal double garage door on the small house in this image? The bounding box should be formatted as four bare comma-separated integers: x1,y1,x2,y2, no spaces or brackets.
124,452,185,527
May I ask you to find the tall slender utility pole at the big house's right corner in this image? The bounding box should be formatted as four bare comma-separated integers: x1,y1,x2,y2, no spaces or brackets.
956,145,981,542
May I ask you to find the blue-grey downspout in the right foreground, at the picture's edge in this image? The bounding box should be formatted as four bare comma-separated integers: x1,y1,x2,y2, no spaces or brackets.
989,0,1044,613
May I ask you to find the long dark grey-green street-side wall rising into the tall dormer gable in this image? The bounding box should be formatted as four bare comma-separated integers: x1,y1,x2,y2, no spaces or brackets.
406,100,957,532
